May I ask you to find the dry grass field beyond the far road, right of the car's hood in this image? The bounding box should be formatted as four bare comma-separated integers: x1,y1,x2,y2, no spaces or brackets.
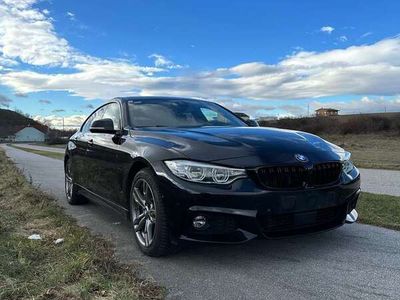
322,134,400,170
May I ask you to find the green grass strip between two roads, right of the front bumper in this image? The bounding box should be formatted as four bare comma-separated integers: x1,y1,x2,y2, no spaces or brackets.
357,192,400,230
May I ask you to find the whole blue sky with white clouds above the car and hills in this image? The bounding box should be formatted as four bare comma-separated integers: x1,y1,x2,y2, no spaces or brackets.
0,0,400,127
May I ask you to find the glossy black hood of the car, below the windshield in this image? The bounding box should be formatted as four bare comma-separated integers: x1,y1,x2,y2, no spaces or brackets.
136,127,344,167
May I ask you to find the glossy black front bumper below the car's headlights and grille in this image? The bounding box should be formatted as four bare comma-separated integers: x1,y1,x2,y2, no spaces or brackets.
157,162,360,243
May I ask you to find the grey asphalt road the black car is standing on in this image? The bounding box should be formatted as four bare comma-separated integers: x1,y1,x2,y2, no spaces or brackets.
3,146,400,299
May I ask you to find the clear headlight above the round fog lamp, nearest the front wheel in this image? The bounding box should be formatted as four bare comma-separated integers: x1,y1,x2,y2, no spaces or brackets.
165,160,246,184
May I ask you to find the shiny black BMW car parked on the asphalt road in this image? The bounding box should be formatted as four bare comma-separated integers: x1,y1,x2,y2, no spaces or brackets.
65,97,360,256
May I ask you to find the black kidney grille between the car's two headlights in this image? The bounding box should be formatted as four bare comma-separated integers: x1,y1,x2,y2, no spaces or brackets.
257,162,342,189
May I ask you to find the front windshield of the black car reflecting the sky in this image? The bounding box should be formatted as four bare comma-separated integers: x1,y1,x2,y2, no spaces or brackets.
127,99,247,127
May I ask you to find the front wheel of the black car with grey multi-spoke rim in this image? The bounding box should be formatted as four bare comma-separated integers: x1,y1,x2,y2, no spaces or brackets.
129,168,177,257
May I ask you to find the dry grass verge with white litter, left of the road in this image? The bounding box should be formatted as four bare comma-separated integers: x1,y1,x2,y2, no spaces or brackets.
0,150,164,300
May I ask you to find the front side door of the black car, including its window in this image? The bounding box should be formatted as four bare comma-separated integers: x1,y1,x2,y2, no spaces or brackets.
86,102,126,204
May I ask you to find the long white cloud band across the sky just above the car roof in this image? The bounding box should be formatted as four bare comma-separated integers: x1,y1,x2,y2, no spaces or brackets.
0,37,400,100
